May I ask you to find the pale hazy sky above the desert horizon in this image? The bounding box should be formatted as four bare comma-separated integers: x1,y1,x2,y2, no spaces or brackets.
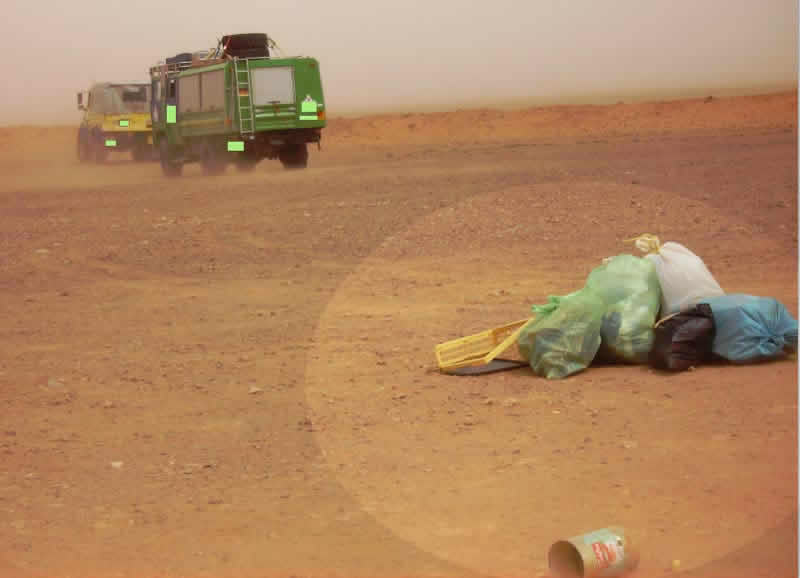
0,0,798,124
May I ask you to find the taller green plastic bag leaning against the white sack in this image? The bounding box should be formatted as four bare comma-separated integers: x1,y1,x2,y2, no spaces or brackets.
585,255,661,363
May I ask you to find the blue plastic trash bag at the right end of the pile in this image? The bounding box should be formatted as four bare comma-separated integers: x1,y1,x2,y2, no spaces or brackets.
702,294,797,363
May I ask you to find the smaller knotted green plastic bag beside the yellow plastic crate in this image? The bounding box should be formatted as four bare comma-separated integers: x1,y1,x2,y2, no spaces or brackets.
517,290,605,379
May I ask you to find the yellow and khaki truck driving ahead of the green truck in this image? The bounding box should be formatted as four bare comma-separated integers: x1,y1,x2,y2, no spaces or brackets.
78,82,156,163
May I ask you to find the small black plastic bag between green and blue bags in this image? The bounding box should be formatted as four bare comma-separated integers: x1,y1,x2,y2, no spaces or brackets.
648,303,715,371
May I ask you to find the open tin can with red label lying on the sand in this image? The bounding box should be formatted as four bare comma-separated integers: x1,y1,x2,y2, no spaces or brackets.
547,526,639,578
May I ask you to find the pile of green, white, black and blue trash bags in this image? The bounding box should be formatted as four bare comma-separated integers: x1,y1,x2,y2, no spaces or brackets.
517,234,797,379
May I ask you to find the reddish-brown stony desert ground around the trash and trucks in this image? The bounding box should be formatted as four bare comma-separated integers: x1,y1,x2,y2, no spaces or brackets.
0,93,798,577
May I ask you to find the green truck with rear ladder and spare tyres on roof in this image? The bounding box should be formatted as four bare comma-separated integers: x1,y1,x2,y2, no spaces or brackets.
150,33,326,176
